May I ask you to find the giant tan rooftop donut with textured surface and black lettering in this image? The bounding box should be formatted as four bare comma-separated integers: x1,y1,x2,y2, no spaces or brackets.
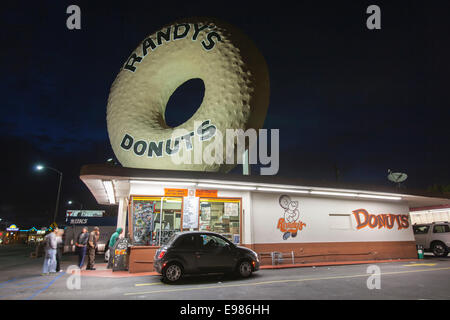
107,18,270,171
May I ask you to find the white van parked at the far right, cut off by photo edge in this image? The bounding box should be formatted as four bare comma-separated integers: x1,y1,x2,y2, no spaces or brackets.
413,222,450,257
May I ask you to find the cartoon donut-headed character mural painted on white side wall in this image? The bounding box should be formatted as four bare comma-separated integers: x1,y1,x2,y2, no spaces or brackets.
277,195,306,240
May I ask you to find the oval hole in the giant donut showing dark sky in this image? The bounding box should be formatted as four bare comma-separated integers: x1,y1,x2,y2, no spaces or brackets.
164,78,205,128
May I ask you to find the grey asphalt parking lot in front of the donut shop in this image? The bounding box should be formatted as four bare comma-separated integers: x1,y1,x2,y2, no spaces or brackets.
0,248,450,300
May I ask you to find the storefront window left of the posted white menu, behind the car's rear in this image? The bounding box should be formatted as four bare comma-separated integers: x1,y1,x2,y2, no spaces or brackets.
132,197,183,246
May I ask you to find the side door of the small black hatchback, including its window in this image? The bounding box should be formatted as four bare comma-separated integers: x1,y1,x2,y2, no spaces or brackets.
196,234,235,272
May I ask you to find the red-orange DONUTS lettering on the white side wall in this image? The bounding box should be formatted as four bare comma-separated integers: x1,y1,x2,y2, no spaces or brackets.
353,209,409,230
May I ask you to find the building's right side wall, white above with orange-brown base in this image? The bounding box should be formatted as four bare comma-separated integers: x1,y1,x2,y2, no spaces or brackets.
246,192,417,264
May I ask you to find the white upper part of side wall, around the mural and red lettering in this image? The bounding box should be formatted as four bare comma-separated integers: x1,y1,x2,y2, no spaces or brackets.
252,193,414,243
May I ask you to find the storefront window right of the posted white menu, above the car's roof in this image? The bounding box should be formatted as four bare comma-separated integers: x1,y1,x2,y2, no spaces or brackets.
199,198,241,243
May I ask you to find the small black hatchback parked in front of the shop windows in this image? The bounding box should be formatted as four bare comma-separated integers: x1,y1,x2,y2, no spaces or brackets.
154,231,259,282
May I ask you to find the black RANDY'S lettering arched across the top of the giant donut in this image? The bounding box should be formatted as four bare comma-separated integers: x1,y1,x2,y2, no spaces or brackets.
123,23,222,72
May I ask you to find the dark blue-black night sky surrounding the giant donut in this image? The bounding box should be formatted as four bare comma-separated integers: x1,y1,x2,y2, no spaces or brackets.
0,0,450,228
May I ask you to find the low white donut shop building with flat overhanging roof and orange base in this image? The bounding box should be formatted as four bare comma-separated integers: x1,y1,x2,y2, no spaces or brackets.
80,165,450,272
